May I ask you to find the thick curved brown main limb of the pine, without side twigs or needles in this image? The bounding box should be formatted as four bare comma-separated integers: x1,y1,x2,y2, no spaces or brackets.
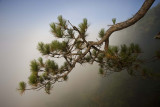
63,0,155,79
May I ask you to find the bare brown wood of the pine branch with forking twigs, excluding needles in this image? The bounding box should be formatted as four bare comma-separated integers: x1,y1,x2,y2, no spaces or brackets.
19,0,155,93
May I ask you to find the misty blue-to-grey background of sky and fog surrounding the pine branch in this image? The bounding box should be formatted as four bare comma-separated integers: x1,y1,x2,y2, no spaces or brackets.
0,0,160,107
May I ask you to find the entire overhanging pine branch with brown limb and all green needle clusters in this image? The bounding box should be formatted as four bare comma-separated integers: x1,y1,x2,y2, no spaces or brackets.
18,0,160,94
